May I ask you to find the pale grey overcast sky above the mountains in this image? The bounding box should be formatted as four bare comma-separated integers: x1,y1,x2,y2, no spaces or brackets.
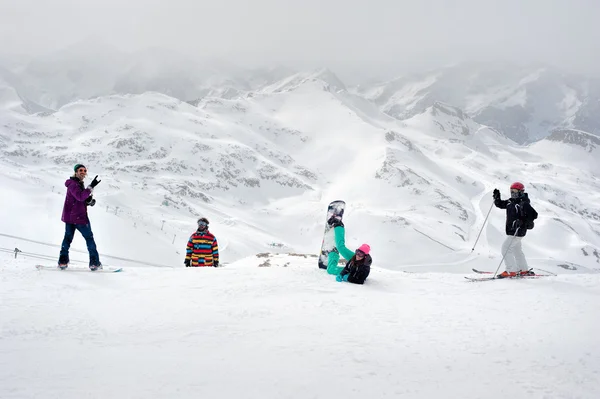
0,0,600,77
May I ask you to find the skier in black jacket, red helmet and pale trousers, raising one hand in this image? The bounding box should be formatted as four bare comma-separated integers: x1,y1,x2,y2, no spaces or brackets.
493,182,538,278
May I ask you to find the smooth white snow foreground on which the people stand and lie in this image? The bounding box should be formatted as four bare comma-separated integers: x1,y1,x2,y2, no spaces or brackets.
0,255,600,399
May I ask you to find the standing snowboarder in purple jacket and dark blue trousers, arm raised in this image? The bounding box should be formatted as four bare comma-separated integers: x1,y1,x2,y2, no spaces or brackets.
58,164,102,271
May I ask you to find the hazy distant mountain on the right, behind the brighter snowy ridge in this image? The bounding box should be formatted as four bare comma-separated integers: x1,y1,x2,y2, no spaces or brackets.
355,63,600,143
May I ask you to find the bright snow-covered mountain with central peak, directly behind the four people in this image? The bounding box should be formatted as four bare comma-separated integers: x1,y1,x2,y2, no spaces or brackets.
0,71,600,269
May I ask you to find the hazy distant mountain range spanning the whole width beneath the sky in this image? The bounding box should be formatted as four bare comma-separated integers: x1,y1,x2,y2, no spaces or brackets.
0,39,600,144
